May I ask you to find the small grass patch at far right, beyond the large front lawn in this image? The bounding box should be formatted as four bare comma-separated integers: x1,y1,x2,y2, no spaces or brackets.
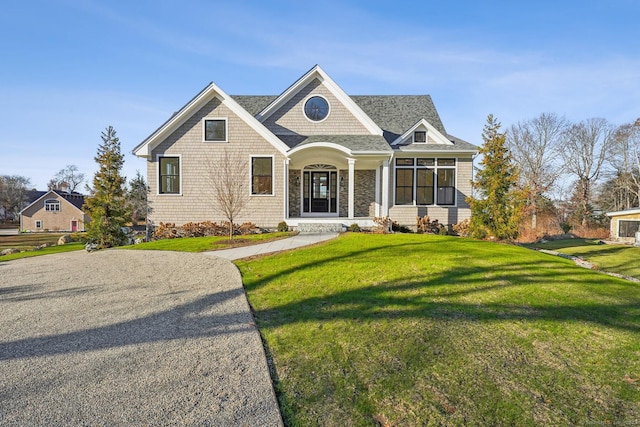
529,239,640,279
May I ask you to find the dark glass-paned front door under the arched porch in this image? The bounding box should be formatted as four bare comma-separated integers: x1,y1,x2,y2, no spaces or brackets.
303,171,338,213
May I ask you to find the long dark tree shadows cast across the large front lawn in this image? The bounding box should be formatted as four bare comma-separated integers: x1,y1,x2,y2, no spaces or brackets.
249,240,640,332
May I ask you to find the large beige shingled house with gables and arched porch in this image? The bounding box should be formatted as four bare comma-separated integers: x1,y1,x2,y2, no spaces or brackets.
133,65,478,229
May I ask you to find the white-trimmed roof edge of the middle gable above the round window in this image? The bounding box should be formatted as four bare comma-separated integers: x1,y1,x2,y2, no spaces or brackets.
256,65,382,135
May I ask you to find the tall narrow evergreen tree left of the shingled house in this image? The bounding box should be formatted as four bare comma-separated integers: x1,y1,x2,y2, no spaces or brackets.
84,126,127,249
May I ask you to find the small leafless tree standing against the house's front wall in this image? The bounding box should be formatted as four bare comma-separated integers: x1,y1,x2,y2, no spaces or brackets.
207,149,249,240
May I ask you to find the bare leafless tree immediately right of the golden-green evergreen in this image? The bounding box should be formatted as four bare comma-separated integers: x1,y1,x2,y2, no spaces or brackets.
507,113,567,229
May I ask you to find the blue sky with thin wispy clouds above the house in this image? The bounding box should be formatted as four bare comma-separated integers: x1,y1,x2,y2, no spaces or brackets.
0,0,640,189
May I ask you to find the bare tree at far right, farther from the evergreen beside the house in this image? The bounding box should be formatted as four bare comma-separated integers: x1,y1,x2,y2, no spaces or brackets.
561,118,615,226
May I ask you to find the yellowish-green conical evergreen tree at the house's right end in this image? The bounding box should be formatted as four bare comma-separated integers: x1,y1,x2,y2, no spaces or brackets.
467,114,523,240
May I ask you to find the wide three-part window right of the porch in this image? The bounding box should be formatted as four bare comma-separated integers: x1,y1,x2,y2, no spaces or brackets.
395,158,456,206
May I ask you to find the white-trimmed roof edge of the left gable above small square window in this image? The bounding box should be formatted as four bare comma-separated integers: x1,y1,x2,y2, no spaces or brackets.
132,82,288,157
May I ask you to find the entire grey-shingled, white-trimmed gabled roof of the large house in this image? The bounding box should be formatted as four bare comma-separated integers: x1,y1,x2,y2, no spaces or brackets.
133,65,478,157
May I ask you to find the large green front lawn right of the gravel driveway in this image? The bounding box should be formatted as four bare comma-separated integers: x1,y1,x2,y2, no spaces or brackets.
237,233,640,426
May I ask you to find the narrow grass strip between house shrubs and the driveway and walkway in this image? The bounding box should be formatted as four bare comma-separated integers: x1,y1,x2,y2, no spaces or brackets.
122,232,293,252
